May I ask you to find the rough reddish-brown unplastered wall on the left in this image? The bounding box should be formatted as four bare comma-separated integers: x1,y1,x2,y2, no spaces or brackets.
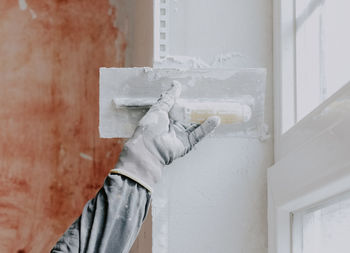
0,0,126,253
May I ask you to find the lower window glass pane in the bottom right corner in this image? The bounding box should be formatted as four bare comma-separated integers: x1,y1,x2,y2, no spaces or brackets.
301,198,350,253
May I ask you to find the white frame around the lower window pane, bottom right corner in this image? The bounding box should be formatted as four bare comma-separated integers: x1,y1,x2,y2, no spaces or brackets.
268,121,350,253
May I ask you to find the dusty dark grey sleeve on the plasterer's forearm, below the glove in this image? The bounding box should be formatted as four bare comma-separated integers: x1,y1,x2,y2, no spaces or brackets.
51,174,151,253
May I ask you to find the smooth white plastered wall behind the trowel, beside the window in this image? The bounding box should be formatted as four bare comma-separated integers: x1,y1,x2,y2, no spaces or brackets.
153,0,273,253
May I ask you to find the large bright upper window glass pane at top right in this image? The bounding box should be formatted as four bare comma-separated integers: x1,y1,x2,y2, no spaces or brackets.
295,0,350,120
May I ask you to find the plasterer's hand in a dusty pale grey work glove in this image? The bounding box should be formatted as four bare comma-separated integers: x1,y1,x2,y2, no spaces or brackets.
111,81,220,191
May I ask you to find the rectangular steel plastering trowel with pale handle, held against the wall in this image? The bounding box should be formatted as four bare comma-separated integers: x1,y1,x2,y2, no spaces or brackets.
99,68,266,138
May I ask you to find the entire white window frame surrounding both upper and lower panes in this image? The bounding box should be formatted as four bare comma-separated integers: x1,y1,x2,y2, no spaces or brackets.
268,0,350,253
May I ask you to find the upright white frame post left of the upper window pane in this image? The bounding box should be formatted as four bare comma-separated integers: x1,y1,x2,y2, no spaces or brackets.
273,0,336,161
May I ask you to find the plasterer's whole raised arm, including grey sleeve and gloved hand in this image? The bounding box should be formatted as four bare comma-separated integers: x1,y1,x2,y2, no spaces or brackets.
52,83,220,253
